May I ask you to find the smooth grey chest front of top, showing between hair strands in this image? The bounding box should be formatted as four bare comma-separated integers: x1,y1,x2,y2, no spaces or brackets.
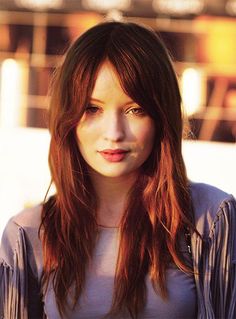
44,229,196,319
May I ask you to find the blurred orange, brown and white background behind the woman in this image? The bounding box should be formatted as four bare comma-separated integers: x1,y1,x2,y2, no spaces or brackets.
0,0,236,236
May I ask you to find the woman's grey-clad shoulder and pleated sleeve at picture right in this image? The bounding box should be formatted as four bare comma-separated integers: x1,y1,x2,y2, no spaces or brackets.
191,184,236,319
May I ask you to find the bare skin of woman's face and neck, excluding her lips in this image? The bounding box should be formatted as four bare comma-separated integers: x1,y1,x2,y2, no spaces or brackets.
76,62,155,227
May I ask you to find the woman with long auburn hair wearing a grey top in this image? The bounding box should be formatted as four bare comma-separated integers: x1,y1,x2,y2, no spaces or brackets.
0,22,236,319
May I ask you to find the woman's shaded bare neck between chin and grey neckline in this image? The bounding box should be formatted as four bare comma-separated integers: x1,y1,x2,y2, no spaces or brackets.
91,173,137,227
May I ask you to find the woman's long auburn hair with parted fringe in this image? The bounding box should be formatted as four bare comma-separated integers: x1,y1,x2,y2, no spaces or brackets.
41,22,194,318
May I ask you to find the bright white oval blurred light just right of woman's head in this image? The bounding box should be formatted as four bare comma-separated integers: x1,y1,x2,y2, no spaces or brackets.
181,68,204,116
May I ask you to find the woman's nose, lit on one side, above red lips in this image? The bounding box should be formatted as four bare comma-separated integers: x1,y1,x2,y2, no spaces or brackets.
103,112,125,142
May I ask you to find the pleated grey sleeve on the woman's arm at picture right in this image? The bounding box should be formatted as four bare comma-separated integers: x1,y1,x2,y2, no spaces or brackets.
203,197,236,319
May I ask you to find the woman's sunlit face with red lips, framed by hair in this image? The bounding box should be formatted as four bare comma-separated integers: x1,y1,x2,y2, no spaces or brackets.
76,62,155,177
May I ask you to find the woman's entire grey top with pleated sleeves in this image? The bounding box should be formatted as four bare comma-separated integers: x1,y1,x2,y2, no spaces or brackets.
0,184,236,319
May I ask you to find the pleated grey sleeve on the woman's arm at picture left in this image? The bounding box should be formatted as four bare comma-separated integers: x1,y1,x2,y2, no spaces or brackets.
0,219,42,319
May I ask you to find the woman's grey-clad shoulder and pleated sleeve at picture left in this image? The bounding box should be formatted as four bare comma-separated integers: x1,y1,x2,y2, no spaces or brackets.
0,206,43,318
